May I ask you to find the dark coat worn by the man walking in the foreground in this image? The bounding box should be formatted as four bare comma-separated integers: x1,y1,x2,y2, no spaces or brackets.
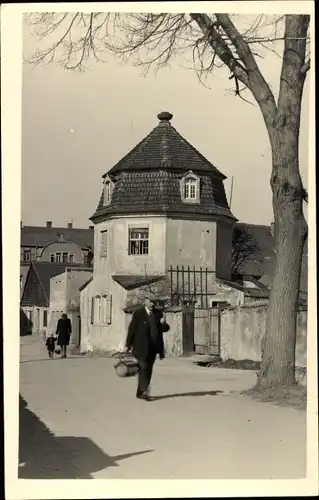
126,307,169,361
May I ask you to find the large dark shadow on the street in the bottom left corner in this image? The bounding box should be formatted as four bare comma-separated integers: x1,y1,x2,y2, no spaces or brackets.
18,394,153,479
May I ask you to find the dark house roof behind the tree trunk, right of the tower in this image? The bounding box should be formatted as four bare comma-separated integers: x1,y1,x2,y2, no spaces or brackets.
234,222,308,292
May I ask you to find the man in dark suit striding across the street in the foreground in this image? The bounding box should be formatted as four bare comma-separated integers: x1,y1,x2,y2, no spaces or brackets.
126,297,169,401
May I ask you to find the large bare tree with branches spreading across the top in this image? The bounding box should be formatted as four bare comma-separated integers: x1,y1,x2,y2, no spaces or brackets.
27,12,310,390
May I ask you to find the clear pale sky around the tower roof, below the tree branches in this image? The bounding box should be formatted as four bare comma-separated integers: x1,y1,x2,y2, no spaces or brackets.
21,13,309,227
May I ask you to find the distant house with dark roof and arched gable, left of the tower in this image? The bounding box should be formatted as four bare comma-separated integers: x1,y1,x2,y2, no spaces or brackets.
20,221,94,297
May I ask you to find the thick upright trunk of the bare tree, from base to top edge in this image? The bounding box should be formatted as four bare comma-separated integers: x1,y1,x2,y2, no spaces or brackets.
257,16,309,389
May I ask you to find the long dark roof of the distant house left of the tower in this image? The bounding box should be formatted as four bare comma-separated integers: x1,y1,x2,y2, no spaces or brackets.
21,226,94,249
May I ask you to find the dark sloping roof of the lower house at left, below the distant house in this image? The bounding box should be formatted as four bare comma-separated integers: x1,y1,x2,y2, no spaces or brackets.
21,261,92,307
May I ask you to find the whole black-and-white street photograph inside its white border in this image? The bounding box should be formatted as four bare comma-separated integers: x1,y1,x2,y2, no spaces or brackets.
1,3,312,494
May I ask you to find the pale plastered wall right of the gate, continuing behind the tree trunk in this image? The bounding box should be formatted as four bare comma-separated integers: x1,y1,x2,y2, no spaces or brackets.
221,303,307,367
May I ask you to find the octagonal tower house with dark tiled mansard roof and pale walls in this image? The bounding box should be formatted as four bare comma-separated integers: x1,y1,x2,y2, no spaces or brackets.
81,112,236,351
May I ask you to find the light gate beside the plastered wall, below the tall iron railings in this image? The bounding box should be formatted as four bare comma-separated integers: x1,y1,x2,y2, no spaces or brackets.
194,307,220,356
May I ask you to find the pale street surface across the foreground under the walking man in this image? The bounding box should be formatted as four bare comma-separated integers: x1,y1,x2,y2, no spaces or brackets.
19,336,306,479
